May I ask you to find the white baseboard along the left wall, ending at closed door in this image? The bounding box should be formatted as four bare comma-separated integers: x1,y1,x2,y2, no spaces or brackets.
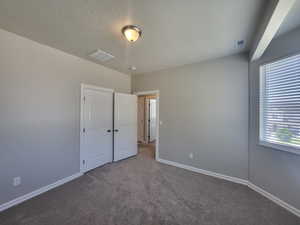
0,173,83,212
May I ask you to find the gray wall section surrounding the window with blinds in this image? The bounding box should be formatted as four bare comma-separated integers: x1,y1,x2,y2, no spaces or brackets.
249,29,300,209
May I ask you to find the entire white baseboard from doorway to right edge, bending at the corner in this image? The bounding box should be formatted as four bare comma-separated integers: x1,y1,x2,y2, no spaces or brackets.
157,158,300,217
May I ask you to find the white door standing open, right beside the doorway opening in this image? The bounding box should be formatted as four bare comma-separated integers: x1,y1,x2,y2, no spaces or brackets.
114,93,137,161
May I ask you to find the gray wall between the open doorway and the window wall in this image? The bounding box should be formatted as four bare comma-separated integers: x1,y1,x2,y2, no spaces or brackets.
132,55,249,179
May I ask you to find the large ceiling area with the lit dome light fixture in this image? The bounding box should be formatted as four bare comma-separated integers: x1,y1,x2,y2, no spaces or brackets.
0,0,265,73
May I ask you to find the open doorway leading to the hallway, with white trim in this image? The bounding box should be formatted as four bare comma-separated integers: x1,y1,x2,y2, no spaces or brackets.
136,91,159,160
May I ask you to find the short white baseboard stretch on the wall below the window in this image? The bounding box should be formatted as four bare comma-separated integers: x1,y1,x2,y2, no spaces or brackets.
248,182,300,217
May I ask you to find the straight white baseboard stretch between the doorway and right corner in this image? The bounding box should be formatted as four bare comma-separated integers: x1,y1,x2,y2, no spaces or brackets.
157,158,248,185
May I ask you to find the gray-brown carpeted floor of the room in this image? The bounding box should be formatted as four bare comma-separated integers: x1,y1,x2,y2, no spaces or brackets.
0,146,300,225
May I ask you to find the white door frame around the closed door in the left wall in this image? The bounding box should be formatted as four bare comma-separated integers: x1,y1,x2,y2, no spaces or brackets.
79,83,114,173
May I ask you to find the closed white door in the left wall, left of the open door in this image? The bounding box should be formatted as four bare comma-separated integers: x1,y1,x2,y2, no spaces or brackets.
80,86,113,172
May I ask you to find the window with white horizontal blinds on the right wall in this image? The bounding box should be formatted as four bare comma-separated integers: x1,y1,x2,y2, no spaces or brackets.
259,54,300,154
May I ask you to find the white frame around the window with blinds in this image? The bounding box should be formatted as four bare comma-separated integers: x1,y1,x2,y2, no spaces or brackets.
258,52,300,155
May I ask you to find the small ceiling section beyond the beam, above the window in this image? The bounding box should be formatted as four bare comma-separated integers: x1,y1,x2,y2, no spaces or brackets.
276,0,300,37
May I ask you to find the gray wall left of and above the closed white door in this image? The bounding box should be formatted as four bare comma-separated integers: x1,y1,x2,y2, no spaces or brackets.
0,30,131,204
